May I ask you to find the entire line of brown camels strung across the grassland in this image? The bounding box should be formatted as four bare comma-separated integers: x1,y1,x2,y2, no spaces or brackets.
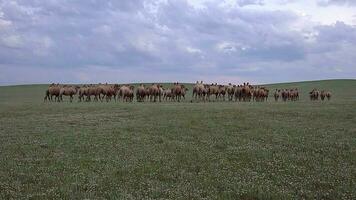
44,81,331,102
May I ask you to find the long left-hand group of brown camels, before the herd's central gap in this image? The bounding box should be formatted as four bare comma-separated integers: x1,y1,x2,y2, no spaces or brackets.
44,83,188,102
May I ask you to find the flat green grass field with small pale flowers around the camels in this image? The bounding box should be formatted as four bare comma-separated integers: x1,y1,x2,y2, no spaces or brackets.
0,80,356,199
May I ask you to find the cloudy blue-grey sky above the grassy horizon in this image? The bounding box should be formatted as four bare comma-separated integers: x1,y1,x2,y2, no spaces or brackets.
0,0,356,85
